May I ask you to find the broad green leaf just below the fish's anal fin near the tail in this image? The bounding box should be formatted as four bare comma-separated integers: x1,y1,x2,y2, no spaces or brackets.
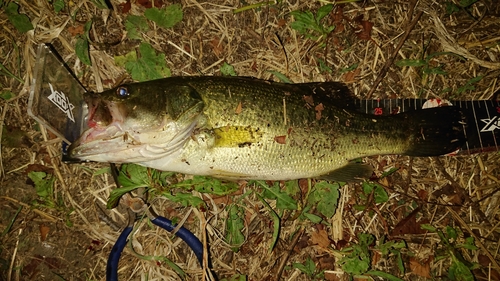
308,181,340,218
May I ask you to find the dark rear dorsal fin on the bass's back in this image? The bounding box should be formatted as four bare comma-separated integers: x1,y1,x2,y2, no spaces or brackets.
295,82,356,110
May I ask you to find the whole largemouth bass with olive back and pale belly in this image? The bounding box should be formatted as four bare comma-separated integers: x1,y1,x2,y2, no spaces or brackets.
69,77,465,180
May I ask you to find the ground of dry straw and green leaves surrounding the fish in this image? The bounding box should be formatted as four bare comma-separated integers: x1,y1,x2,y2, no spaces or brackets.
0,0,500,281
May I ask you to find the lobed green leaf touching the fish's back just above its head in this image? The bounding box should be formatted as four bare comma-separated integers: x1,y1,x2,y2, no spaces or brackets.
125,43,171,81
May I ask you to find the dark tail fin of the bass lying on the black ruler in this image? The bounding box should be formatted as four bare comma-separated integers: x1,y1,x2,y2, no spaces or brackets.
401,106,466,156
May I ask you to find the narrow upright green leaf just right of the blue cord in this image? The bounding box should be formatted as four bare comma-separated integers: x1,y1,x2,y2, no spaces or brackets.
226,202,245,252
